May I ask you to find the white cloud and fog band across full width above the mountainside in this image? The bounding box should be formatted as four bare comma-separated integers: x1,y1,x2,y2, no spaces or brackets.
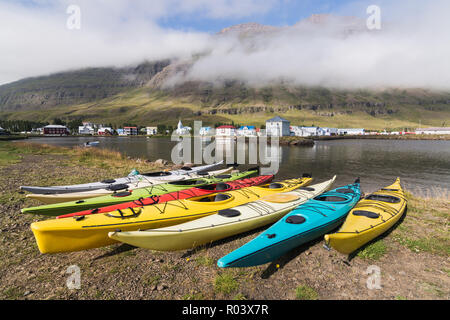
0,0,450,90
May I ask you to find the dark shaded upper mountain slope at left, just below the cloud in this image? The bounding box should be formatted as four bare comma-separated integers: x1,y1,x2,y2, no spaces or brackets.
0,60,170,111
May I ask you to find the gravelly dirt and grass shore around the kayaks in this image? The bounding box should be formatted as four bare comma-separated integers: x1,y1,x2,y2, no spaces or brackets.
0,150,450,300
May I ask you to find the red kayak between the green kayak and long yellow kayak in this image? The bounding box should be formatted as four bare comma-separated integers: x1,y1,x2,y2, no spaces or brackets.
56,175,274,219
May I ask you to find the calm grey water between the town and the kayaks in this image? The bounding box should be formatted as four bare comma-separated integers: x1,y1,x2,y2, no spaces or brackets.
24,137,450,192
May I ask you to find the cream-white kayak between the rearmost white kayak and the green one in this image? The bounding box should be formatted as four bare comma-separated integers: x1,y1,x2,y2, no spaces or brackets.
26,167,234,204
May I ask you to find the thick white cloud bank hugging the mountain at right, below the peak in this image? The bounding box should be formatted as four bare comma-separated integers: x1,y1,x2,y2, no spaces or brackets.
179,0,450,89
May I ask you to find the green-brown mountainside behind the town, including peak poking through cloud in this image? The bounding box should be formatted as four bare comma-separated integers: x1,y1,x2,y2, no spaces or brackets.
0,15,450,129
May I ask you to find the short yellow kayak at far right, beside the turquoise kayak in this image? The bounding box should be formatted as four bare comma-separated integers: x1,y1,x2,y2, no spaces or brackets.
325,178,406,254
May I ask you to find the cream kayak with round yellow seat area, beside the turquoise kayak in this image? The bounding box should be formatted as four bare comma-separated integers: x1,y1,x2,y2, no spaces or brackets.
108,176,336,251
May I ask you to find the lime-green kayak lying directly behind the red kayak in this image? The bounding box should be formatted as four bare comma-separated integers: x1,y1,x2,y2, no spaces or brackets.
22,169,258,216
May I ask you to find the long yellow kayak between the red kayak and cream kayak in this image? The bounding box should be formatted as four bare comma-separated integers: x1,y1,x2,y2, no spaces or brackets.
31,177,312,253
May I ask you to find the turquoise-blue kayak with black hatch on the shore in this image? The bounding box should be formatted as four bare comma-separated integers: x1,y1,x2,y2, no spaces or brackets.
217,180,361,268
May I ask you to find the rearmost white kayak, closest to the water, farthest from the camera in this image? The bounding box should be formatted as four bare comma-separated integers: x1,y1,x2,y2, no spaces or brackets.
20,160,223,194
